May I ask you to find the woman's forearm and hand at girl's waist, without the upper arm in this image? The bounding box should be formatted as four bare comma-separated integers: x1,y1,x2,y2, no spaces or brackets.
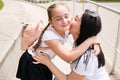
33,52,67,80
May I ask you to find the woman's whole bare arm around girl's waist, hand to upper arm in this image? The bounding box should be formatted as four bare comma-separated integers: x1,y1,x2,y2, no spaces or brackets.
33,52,85,80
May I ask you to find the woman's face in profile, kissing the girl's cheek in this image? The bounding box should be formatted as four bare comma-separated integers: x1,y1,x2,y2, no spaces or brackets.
70,12,83,36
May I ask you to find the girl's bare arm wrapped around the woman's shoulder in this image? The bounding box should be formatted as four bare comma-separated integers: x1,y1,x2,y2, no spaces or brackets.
45,36,96,62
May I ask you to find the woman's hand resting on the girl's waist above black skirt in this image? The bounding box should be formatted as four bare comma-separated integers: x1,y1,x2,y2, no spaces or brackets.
33,52,51,65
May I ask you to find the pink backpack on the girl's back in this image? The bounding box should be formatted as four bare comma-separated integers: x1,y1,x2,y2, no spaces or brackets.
21,21,43,51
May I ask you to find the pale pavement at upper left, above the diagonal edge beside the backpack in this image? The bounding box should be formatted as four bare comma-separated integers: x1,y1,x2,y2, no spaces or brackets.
0,0,47,65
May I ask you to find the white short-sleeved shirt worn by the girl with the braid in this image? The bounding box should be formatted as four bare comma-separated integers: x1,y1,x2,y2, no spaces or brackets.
28,25,69,59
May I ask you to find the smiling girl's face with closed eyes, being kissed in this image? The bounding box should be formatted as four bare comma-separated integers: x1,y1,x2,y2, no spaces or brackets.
49,5,71,34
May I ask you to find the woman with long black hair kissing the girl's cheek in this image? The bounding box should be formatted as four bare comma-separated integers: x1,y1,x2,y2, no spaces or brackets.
33,10,110,80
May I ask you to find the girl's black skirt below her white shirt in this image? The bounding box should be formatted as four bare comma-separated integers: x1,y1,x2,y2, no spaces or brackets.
16,50,53,80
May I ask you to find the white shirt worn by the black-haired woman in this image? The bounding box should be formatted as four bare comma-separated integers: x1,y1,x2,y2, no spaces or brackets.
71,49,110,80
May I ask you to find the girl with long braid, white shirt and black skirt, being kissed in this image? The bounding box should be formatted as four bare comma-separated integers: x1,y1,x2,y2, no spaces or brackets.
17,3,96,80
